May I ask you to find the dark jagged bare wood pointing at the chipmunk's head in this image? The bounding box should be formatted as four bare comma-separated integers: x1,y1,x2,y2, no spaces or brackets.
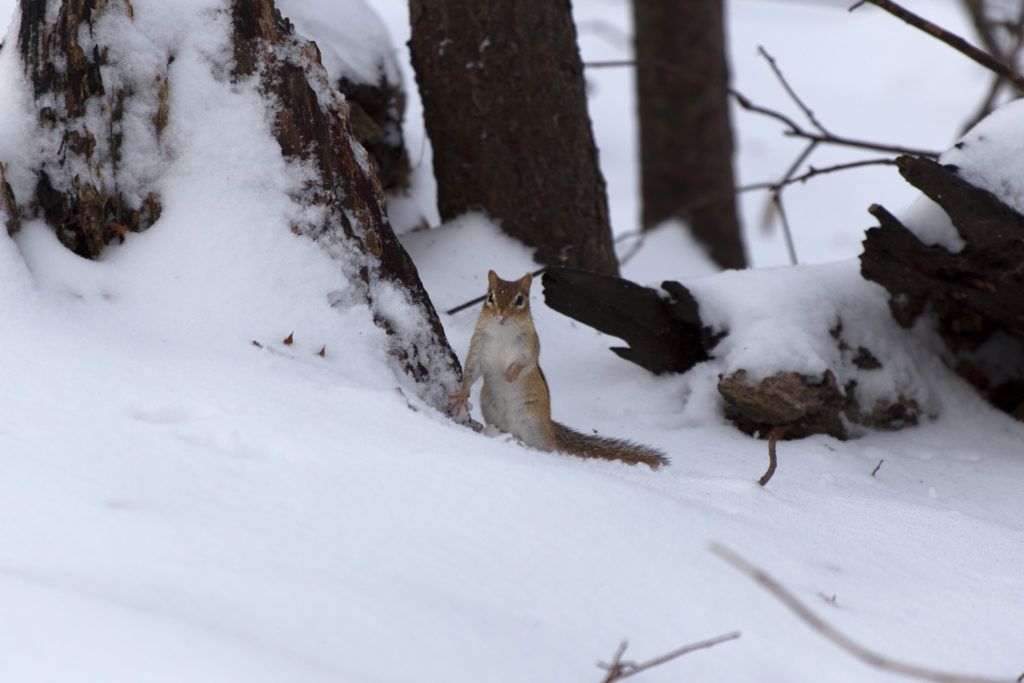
542,268,713,375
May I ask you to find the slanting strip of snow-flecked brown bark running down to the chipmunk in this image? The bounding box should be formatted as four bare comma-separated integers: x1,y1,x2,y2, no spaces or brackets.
232,0,461,410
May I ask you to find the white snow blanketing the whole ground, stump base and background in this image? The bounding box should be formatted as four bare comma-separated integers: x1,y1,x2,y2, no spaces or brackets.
0,0,1024,683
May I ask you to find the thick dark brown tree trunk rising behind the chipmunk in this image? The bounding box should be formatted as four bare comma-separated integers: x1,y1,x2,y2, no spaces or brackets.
410,0,618,273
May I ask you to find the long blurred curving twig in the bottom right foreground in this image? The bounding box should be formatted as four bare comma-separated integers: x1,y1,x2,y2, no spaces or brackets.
711,543,1012,683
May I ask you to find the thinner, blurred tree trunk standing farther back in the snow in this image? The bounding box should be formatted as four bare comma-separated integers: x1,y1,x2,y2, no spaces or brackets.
633,0,746,268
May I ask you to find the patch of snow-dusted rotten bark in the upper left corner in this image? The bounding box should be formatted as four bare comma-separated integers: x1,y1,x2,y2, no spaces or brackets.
12,0,167,258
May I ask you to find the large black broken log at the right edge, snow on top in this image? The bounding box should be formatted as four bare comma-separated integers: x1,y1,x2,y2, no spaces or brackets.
860,157,1024,419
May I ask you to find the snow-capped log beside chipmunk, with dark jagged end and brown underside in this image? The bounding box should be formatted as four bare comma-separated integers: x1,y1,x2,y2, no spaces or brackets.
543,262,930,439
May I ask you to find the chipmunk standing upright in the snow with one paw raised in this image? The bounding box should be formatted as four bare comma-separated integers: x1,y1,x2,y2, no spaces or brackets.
449,270,669,468
